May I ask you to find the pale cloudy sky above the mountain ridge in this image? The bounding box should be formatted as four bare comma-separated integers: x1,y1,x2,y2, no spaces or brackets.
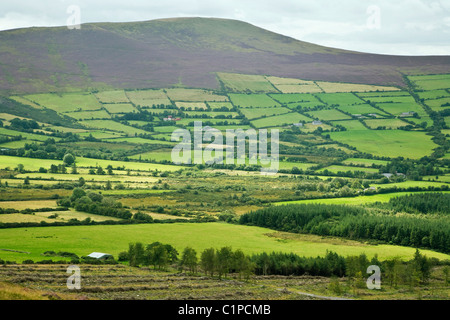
0,0,450,55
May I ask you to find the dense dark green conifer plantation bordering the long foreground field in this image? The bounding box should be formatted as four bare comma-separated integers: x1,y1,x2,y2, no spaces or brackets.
239,204,450,253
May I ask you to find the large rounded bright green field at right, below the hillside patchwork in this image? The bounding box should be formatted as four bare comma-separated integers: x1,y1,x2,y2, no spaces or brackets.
329,130,437,159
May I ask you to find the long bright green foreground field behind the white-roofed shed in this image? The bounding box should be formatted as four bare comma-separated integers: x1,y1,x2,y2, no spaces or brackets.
0,223,449,261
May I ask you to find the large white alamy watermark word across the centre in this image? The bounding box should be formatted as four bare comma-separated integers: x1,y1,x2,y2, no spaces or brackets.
171,121,280,174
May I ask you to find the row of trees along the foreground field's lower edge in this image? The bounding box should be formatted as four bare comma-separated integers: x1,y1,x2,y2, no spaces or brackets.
118,242,442,286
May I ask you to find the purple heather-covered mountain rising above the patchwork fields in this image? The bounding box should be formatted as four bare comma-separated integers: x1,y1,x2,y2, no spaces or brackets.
0,18,450,94
